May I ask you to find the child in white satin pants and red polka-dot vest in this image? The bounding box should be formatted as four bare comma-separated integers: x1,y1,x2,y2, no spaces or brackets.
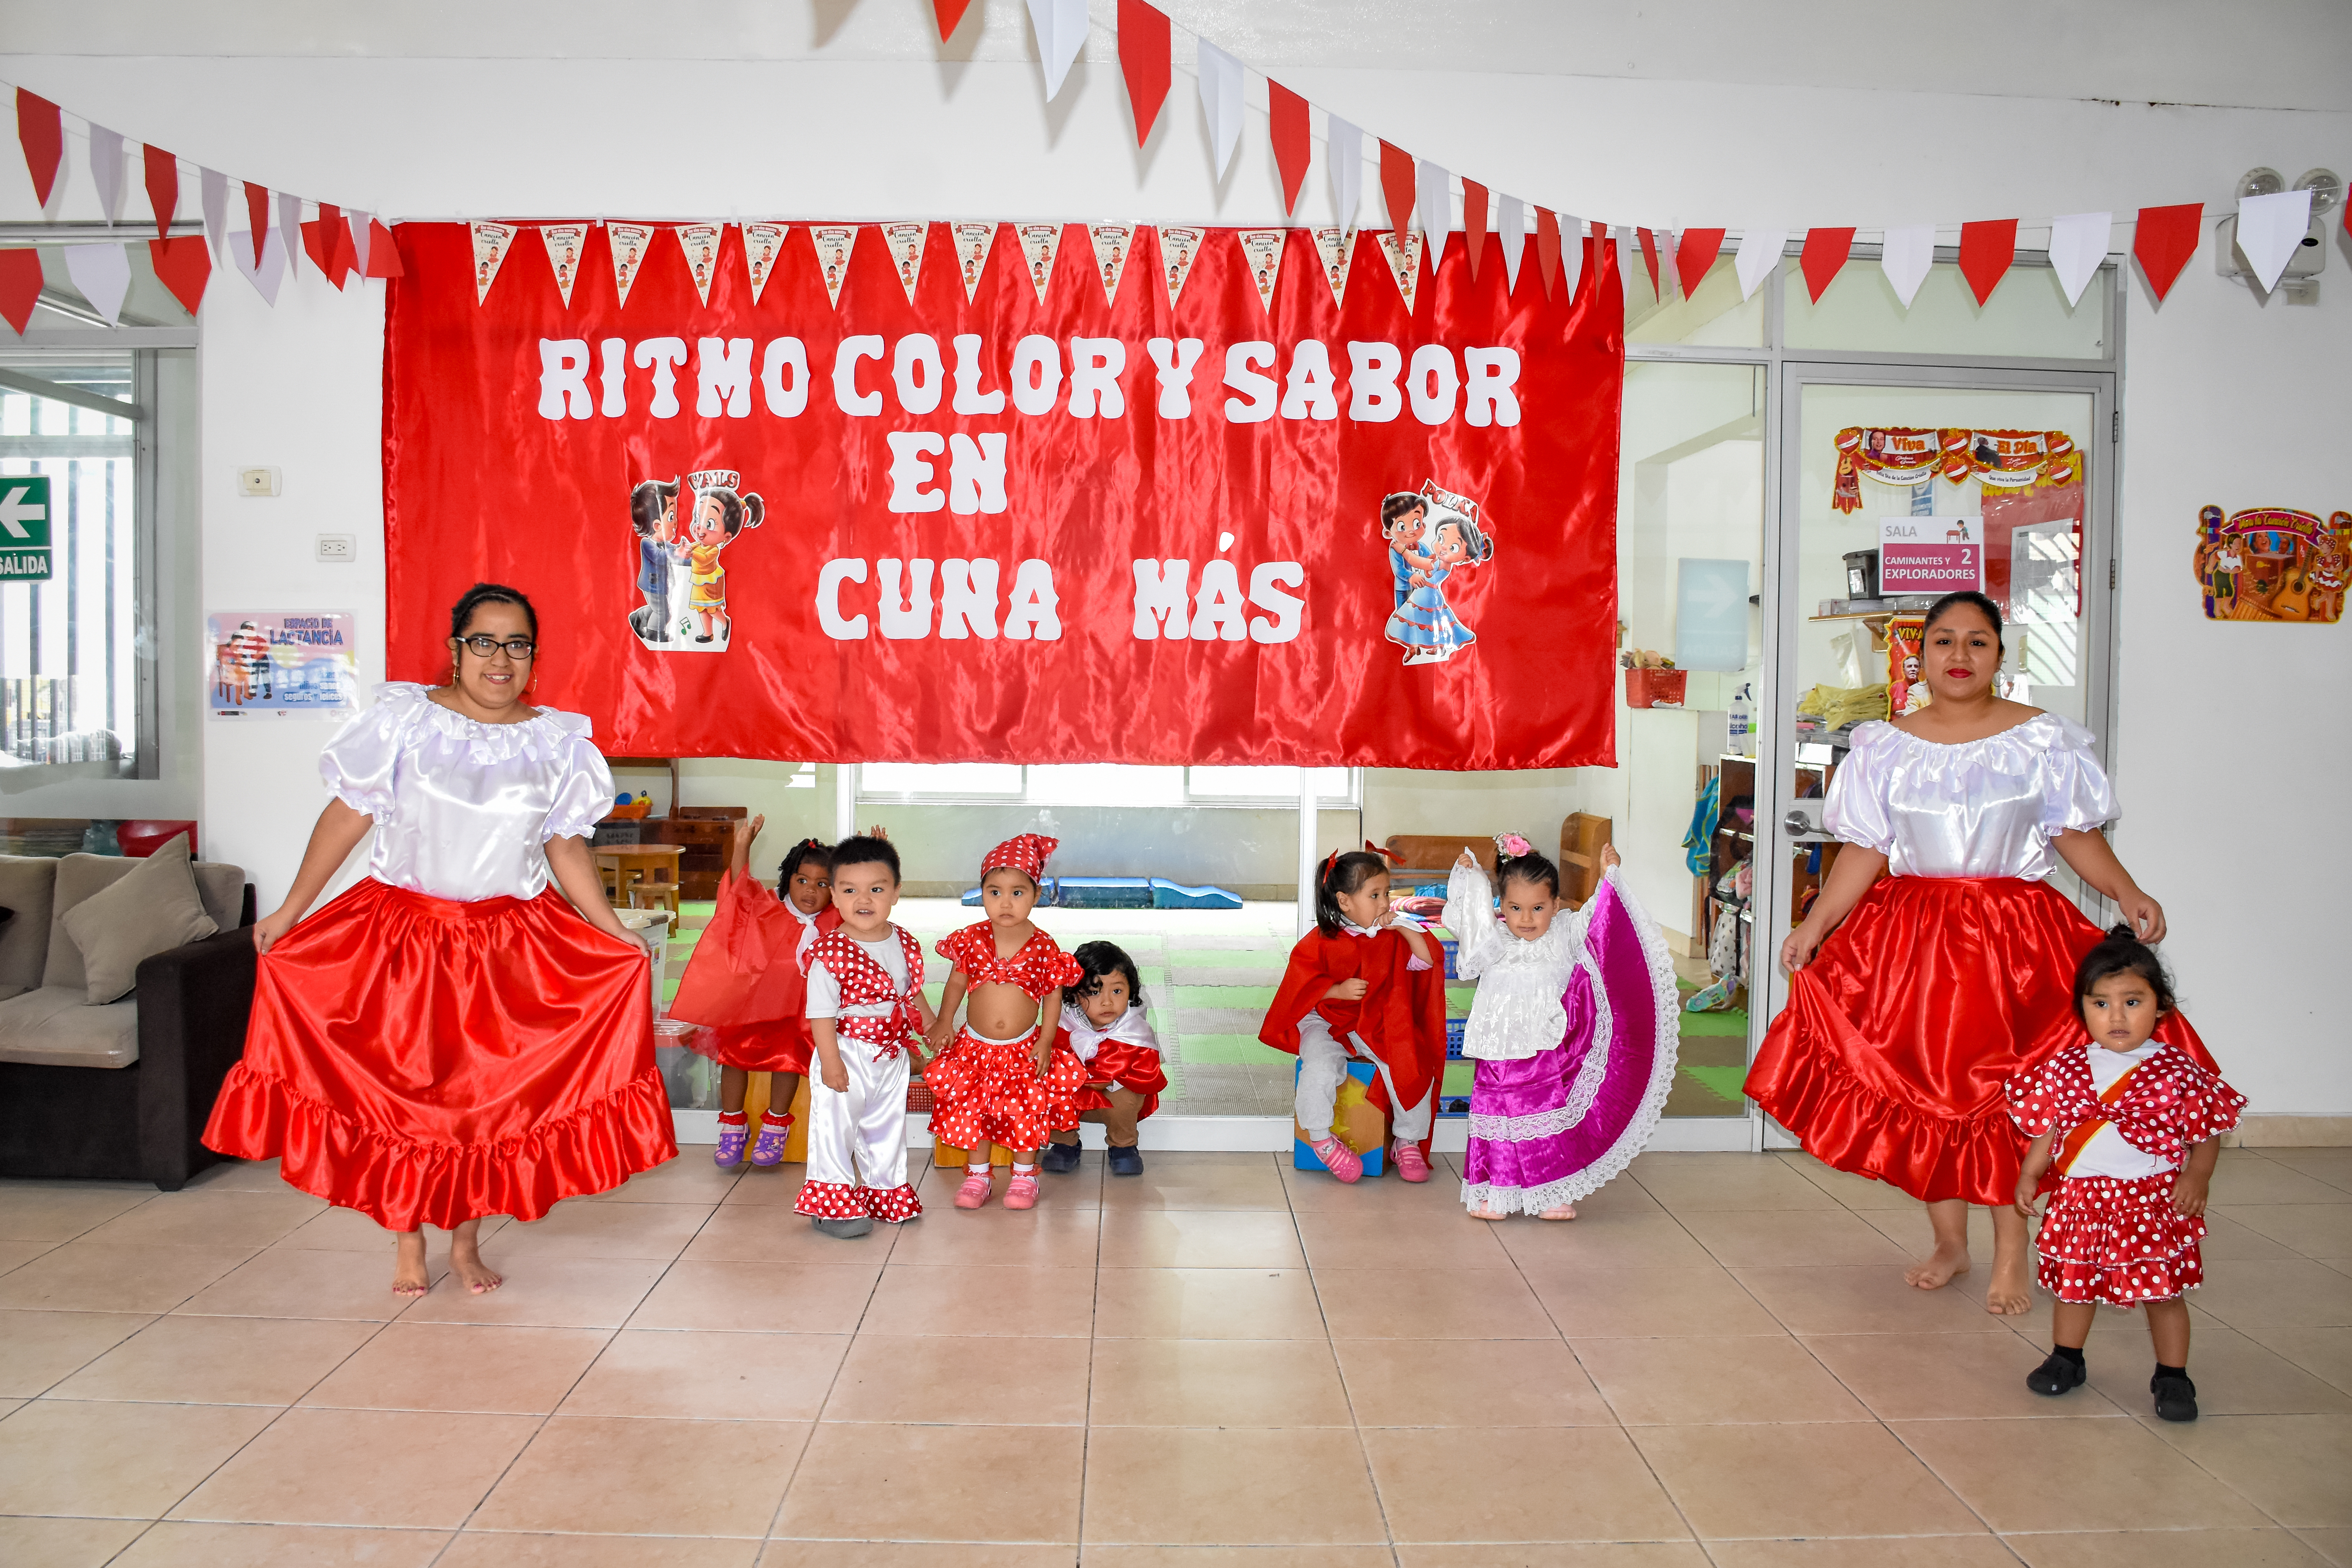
793,834,932,1237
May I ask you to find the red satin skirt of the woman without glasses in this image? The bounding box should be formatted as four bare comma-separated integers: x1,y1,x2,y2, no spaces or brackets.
1747,877,2213,1206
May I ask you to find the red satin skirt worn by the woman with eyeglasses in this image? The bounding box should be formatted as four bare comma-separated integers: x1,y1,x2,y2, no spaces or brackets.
205,879,677,1230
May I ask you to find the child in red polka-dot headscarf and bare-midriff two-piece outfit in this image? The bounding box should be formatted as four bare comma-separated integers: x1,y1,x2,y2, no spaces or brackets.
922,832,1087,1208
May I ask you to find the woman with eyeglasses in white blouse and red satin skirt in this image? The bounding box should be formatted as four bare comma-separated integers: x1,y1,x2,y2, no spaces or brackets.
205,583,677,1295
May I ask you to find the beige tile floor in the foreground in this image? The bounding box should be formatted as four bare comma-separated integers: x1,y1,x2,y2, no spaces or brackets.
0,1150,2352,1568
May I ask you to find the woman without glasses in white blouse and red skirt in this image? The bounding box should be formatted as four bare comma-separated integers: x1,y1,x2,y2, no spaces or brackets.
1747,592,2211,1316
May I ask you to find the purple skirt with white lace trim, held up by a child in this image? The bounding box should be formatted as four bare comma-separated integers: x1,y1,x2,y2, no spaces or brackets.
1463,872,1682,1213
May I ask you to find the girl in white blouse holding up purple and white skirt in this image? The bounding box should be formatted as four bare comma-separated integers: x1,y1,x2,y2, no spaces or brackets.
1446,832,1682,1220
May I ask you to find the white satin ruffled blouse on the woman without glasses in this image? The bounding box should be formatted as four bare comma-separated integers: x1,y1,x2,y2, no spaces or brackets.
1821,713,2117,882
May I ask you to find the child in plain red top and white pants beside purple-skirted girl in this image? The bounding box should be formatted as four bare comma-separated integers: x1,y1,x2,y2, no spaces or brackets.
1258,848,1446,1182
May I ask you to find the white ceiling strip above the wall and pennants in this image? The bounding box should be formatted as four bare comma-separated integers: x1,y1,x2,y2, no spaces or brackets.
0,0,2352,110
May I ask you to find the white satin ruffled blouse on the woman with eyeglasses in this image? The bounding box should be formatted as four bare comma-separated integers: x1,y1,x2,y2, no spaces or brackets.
317,682,612,903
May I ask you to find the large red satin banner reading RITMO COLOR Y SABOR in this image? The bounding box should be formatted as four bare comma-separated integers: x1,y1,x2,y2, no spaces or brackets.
384,223,1623,769
